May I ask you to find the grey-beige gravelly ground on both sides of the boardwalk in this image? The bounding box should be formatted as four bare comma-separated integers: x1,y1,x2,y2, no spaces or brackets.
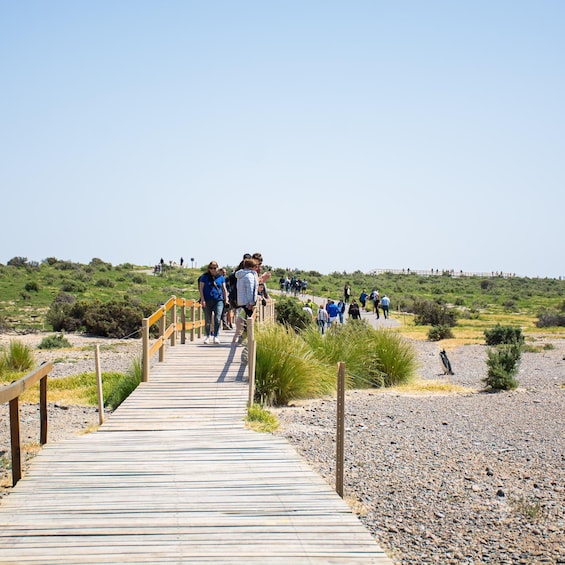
0,328,565,565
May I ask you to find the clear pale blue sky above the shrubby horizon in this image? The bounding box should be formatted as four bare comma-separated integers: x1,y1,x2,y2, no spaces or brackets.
0,0,565,277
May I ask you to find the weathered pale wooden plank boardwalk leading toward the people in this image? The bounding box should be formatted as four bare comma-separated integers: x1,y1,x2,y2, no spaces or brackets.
0,336,391,565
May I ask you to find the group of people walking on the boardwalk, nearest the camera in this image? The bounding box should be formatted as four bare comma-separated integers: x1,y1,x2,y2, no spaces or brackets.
198,253,271,344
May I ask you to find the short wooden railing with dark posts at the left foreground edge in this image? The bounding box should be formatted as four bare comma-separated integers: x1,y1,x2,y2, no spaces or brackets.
0,362,53,486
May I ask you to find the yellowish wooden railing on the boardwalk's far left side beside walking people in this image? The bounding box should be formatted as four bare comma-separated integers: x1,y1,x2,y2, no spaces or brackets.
141,296,204,382
